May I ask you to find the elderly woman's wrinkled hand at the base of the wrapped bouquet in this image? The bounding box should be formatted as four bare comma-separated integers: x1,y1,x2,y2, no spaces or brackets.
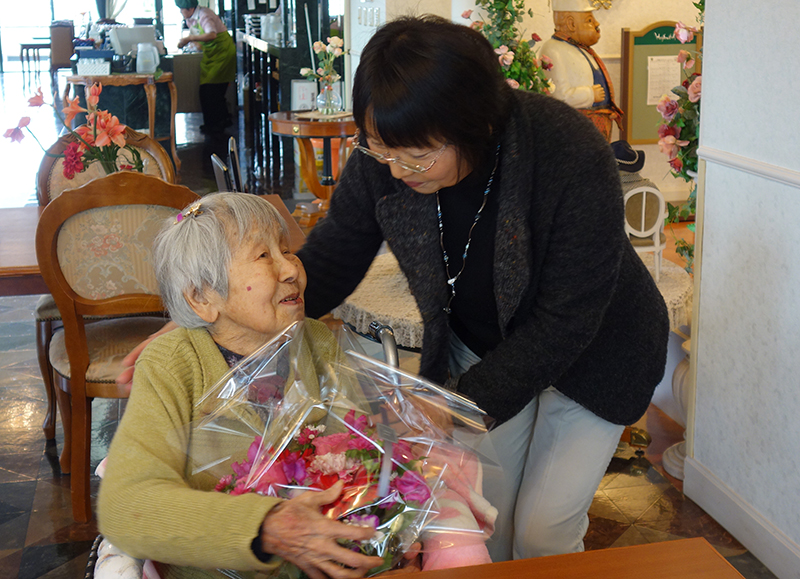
261,481,383,579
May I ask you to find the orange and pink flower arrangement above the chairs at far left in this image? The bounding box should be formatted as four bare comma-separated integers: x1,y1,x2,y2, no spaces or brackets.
4,83,144,179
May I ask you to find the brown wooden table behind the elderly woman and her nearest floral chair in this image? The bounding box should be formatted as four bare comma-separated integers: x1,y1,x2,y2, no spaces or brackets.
0,195,305,296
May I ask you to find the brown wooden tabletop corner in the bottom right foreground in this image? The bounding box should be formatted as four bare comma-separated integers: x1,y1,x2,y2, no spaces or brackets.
410,538,743,579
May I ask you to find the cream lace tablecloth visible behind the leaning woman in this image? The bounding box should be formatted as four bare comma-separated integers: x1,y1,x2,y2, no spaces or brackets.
333,253,693,348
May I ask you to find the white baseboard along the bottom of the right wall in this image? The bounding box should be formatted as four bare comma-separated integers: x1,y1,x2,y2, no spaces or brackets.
683,457,800,579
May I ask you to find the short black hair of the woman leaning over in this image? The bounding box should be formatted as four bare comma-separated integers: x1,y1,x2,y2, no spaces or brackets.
353,15,514,167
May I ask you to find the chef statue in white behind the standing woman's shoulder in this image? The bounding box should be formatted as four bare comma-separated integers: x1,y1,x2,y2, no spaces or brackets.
541,0,622,141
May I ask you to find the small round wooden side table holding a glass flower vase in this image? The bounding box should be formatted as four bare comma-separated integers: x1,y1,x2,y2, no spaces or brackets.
269,111,356,226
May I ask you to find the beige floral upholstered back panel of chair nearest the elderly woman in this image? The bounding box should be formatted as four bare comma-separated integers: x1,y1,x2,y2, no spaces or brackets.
57,205,176,300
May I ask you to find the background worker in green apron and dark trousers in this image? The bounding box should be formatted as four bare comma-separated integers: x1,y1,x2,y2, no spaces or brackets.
175,0,236,135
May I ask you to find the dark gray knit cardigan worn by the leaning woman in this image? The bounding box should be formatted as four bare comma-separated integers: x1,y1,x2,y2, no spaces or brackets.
299,91,669,424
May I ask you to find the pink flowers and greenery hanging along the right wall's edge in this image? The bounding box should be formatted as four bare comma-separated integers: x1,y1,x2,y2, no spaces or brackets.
656,13,705,273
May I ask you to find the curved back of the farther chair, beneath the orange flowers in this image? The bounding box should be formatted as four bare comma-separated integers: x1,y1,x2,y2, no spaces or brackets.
37,128,175,205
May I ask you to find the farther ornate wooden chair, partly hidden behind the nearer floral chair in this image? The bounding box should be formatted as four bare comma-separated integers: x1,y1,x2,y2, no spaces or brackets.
34,127,175,440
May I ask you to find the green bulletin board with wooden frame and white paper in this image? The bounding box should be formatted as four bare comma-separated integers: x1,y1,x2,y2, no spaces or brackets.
620,21,702,145
